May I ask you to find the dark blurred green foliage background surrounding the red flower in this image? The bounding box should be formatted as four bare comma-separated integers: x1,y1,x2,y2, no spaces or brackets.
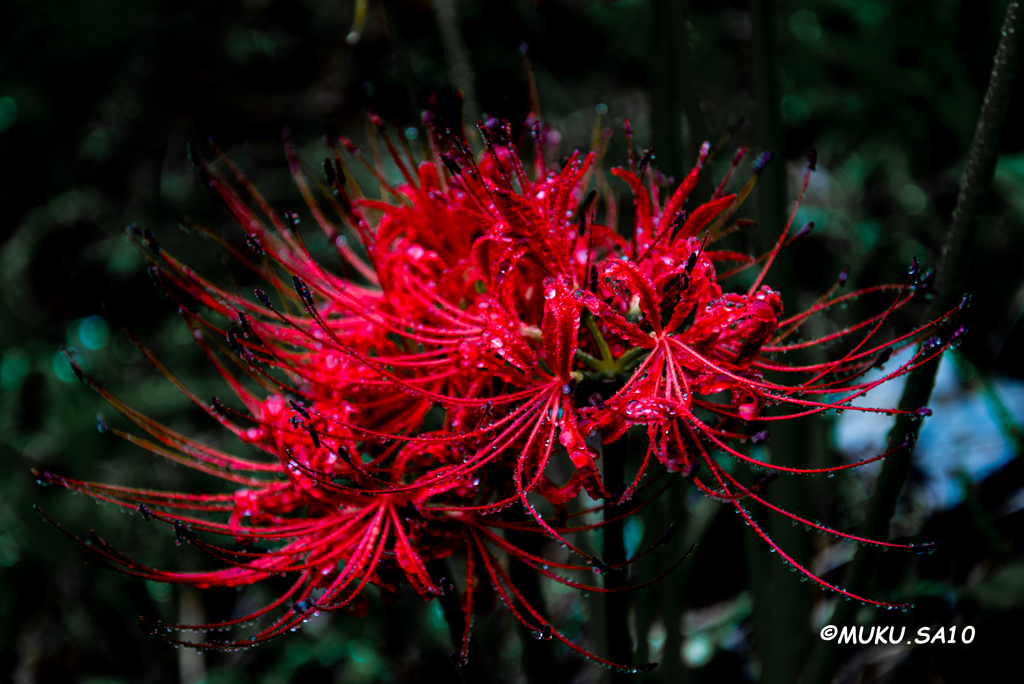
0,0,1024,683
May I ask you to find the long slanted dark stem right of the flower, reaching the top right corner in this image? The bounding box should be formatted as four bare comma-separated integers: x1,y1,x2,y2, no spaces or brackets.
808,0,1022,682
